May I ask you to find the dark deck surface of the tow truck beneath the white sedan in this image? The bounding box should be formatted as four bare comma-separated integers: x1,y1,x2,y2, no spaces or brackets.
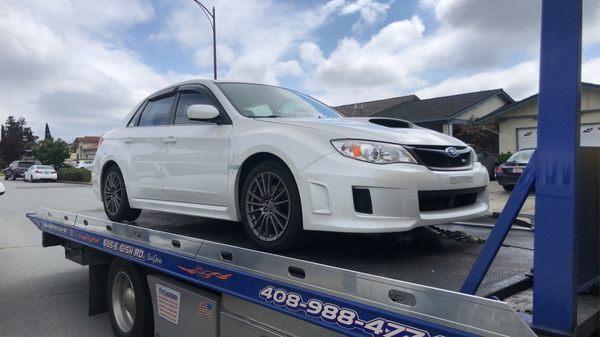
78,209,533,297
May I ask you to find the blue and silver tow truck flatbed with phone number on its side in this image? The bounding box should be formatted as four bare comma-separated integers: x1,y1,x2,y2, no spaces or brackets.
28,209,535,337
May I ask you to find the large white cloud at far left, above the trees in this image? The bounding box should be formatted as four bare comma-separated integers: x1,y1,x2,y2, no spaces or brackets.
0,0,186,141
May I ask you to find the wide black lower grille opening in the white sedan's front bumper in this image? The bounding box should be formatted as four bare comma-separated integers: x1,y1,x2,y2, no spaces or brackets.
419,187,485,212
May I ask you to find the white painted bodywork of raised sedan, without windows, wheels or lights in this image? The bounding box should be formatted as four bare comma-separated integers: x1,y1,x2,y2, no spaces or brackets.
92,80,490,233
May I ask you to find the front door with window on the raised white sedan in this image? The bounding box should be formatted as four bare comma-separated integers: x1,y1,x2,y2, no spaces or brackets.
163,85,232,206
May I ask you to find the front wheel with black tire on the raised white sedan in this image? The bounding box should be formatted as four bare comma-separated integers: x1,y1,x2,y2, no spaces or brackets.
240,160,306,251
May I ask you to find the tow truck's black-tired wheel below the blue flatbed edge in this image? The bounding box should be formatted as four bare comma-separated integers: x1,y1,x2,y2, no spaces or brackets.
106,259,154,337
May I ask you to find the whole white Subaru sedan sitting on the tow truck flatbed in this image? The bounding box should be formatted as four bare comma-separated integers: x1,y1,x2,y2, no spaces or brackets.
92,80,489,250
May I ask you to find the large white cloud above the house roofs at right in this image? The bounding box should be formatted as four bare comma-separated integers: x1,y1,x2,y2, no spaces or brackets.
310,0,600,104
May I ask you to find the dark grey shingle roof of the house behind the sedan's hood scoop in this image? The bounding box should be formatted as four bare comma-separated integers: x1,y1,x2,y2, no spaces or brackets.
375,89,513,122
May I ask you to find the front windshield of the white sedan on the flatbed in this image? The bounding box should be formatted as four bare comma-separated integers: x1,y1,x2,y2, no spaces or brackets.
217,83,341,118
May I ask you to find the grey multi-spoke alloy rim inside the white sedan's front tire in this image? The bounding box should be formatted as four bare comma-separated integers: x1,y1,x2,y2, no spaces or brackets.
244,171,290,241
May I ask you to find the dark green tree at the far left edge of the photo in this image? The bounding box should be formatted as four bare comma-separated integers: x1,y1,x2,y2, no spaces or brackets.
0,116,37,167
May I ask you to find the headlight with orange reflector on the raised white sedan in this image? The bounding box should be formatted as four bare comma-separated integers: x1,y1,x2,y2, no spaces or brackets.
331,139,417,164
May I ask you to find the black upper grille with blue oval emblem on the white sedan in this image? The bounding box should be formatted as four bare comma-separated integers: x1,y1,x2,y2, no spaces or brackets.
406,145,472,170
